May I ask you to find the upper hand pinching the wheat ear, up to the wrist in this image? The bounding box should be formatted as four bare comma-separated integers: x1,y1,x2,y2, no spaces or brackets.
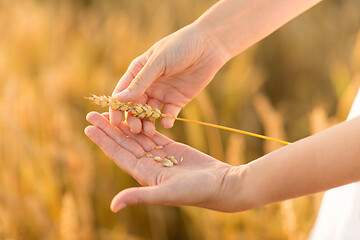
110,24,228,135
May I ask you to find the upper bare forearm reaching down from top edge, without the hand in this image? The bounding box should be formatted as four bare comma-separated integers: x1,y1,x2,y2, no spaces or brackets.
195,0,321,59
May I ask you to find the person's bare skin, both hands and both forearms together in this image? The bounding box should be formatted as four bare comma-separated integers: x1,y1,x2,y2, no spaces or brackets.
85,0,360,212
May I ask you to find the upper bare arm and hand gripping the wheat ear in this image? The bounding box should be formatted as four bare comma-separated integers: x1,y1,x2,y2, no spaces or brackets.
109,0,320,135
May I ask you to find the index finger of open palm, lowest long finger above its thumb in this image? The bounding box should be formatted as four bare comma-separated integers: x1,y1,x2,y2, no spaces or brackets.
84,126,136,173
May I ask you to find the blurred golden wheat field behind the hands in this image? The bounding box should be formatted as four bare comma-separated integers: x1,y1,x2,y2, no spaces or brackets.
0,0,360,240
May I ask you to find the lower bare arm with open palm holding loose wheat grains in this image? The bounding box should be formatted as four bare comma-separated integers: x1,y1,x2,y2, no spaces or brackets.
85,112,360,212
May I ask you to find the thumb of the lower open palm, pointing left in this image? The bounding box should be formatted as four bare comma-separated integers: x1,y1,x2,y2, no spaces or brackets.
110,186,171,212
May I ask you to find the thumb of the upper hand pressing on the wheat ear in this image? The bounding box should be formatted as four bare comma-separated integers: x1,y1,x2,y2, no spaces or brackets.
115,57,164,102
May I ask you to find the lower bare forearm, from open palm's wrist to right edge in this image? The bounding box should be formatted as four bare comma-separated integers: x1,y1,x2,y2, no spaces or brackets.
234,117,360,210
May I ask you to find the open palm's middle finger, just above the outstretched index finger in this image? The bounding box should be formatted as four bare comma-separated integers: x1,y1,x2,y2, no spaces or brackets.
86,112,145,158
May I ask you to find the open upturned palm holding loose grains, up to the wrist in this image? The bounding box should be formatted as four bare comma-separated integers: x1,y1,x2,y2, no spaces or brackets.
85,112,245,212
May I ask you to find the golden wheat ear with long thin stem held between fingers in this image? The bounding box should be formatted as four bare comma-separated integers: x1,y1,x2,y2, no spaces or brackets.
88,95,290,145
